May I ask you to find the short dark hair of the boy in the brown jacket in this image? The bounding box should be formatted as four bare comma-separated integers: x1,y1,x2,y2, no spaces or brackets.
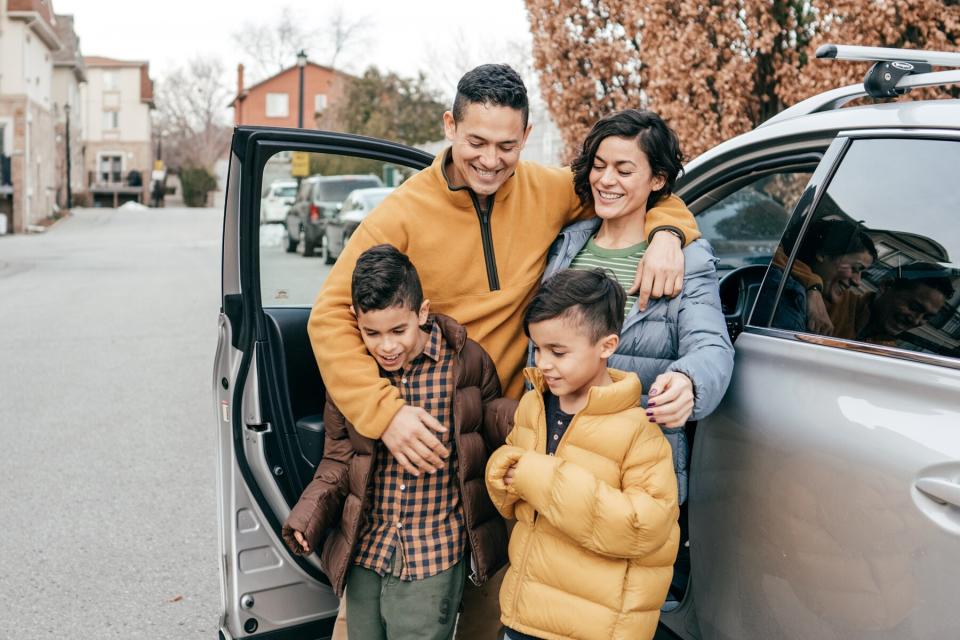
350,244,423,313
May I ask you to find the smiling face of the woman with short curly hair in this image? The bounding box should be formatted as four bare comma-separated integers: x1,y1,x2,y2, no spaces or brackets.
590,136,666,220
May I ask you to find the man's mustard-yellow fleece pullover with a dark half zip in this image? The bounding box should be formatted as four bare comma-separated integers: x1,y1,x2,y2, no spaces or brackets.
307,150,700,438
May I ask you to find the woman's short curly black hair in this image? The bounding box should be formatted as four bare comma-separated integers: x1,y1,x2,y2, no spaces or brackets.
570,109,683,209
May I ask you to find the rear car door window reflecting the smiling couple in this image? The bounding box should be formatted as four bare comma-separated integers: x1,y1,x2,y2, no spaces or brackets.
754,138,960,357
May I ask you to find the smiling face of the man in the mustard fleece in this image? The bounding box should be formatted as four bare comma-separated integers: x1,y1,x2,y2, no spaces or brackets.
443,102,531,196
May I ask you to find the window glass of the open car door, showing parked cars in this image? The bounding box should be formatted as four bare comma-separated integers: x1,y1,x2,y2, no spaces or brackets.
260,153,406,307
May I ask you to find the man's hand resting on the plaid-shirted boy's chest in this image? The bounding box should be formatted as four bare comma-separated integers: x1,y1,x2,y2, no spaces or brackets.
380,405,450,476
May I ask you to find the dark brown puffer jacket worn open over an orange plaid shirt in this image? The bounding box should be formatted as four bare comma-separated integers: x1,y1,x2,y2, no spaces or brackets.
283,315,516,596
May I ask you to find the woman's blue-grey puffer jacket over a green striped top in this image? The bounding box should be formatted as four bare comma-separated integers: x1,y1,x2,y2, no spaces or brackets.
530,218,733,503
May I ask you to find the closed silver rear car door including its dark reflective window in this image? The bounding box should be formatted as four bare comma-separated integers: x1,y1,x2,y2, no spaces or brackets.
690,131,960,640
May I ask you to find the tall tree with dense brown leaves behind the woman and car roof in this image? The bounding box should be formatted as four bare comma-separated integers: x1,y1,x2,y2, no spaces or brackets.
526,0,960,158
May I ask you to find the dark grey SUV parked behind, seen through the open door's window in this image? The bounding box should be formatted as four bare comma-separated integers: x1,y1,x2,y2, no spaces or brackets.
286,175,383,257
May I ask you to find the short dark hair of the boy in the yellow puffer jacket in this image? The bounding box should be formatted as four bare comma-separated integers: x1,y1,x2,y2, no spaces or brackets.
523,269,627,342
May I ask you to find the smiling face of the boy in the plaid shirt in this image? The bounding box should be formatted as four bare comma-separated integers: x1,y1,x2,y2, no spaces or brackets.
357,300,430,371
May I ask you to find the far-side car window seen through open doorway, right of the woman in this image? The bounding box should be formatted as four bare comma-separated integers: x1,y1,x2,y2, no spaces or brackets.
697,171,811,273
